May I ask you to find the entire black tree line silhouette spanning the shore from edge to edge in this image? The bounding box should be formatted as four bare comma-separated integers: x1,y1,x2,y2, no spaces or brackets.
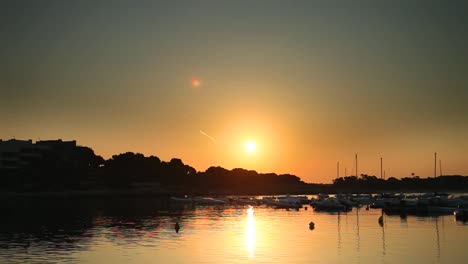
0,146,468,194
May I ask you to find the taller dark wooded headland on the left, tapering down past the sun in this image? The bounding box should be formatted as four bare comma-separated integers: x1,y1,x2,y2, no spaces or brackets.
0,147,306,192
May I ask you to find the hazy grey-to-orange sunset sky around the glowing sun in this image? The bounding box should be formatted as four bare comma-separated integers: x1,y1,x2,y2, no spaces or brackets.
0,0,468,183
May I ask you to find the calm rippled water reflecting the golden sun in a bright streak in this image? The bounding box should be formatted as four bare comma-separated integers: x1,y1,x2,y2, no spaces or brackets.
0,199,468,263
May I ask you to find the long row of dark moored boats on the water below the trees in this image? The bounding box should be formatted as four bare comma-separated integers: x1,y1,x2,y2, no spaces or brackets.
171,193,468,220
